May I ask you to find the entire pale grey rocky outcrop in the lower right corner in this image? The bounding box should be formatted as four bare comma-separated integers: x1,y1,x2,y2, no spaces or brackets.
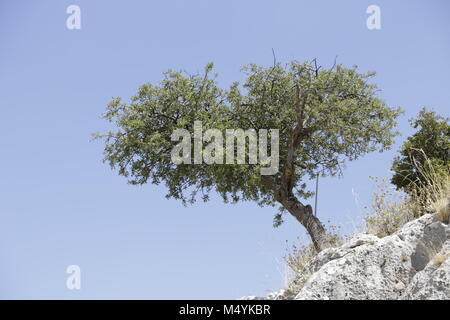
243,214,450,300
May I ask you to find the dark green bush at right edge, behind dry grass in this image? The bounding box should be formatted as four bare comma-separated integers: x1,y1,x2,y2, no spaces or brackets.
391,108,450,193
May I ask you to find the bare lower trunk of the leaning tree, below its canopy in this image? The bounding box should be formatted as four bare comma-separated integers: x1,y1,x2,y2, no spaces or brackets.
279,195,330,252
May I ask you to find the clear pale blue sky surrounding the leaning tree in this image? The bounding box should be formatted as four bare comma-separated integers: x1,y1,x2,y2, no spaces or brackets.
0,0,450,299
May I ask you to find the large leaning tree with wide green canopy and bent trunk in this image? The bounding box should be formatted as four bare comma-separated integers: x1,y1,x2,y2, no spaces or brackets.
98,60,400,251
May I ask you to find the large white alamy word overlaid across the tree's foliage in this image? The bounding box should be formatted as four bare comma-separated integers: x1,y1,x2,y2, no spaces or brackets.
171,121,279,175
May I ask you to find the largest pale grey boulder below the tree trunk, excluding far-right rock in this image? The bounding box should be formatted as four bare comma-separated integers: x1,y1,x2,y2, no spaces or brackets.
296,215,450,300
